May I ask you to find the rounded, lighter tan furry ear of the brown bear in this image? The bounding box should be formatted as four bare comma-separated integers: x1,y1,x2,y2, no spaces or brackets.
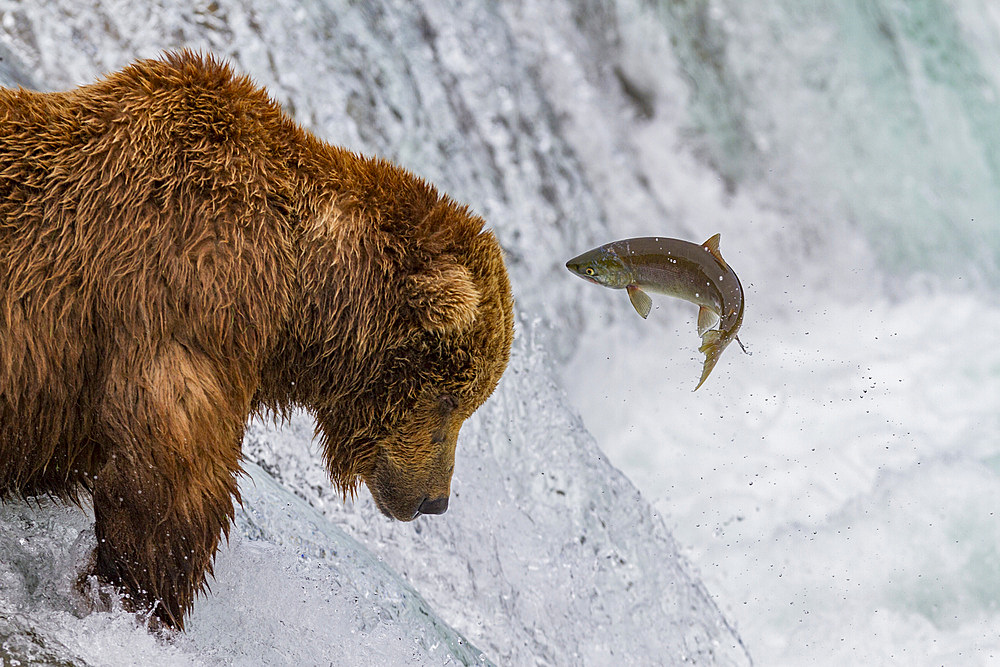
406,262,479,333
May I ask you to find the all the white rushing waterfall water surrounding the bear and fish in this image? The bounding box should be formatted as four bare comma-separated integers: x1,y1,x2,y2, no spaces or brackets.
0,0,1000,665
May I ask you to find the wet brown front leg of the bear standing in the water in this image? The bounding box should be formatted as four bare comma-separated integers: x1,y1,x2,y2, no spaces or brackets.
93,346,248,629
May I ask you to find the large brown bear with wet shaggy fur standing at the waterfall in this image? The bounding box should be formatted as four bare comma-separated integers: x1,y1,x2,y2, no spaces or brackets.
0,52,513,628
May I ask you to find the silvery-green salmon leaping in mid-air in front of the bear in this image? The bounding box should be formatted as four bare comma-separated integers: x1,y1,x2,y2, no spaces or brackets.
566,234,746,391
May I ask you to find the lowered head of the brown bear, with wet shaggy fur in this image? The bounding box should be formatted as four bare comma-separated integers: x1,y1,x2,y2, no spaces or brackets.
286,191,513,521
